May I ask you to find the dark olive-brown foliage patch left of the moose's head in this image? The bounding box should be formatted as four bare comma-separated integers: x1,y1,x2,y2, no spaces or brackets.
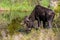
8,17,21,34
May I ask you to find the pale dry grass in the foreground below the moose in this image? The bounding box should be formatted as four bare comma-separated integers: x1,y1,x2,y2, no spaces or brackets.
0,29,59,40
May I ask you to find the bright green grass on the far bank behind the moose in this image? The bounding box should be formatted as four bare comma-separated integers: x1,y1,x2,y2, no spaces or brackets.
0,0,49,11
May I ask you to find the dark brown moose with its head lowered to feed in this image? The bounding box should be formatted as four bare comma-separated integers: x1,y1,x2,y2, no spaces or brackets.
25,5,55,30
